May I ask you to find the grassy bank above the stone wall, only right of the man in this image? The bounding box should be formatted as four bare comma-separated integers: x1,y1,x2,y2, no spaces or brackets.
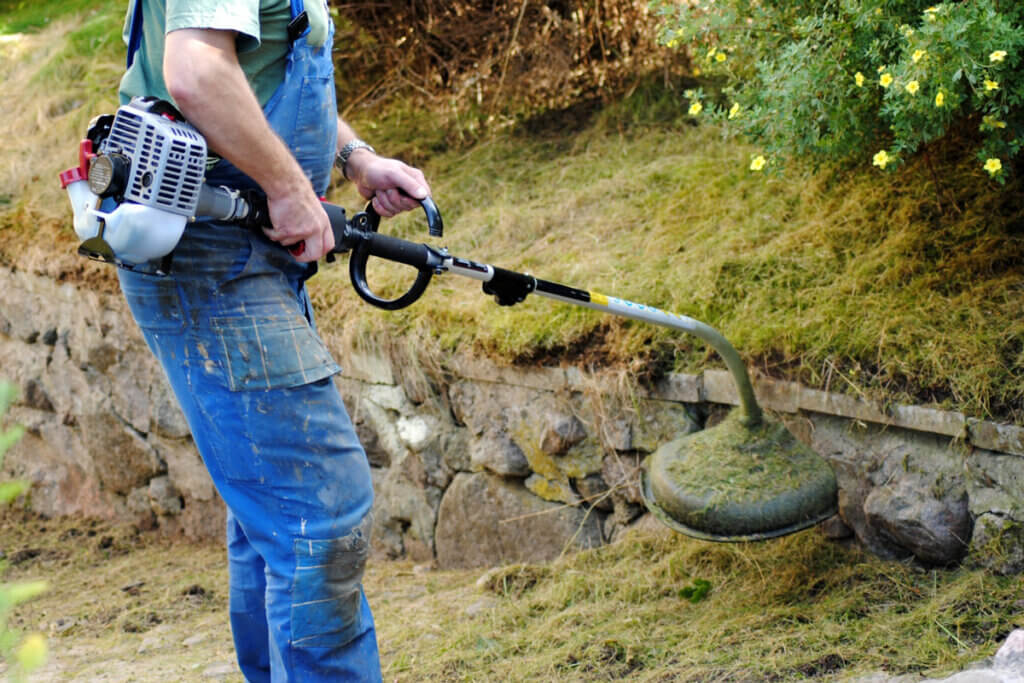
314,111,1024,420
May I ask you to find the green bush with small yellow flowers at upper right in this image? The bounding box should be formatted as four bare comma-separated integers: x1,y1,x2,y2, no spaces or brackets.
651,0,1024,182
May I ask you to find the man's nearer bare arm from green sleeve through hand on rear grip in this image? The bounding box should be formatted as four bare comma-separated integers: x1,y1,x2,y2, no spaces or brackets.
164,29,334,262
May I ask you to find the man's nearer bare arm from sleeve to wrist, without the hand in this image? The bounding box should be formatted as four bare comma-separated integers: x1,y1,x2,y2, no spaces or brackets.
164,29,311,197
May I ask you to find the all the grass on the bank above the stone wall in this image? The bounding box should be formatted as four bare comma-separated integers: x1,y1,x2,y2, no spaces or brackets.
0,3,1024,422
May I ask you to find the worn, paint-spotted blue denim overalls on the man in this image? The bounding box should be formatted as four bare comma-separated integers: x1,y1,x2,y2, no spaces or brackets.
119,0,381,683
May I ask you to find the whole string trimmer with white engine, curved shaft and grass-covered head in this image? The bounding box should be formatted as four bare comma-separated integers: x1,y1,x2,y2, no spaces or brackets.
60,99,837,541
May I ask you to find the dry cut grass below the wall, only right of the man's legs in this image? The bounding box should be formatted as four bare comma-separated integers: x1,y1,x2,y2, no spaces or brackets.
376,532,1024,681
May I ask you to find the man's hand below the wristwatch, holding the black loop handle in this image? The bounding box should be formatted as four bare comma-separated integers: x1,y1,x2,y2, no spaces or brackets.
346,150,430,217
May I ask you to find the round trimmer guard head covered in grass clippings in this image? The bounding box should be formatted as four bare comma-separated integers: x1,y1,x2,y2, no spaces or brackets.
643,411,837,541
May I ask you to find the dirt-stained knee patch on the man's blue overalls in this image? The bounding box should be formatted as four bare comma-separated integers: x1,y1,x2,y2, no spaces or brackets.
291,513,373,648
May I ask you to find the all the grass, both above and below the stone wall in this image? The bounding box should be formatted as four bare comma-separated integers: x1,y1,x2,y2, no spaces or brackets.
0,2,1024,681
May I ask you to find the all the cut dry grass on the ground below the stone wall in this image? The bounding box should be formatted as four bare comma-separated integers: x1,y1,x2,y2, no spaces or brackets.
6,511,1024,682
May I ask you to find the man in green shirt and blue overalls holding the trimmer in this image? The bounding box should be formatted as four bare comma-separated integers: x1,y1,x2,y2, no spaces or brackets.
119,0,429,681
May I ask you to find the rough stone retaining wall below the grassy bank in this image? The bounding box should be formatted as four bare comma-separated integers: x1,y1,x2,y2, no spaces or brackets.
0,271,1024,573
